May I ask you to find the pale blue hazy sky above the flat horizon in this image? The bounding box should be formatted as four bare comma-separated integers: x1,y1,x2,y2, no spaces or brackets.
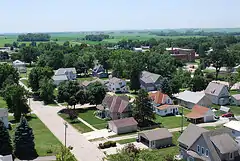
0,0,240,33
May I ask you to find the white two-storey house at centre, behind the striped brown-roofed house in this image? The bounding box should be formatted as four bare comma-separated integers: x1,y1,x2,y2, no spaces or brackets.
107,77,128,93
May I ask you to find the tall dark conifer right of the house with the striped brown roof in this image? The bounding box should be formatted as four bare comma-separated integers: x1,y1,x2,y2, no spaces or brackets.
133,89,155,124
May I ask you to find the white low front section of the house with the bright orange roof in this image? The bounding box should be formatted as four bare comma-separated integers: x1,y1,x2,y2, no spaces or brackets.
155,104,180,116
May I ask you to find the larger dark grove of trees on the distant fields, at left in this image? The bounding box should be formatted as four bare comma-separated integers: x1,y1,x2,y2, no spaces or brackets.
17,33,51,41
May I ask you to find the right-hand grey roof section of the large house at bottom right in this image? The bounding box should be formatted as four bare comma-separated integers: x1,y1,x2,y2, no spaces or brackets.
210,133,238,154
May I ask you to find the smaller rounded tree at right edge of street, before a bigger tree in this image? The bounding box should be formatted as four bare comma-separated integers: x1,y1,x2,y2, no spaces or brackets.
39,78,55,104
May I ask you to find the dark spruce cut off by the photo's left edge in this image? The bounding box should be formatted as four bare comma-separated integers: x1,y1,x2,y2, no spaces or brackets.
0,120,13,155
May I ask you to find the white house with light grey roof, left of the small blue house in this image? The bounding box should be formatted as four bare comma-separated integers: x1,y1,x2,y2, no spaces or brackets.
52,68,77,85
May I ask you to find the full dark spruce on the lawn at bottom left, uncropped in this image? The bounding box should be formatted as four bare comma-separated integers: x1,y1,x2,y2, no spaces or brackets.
14,117,38,160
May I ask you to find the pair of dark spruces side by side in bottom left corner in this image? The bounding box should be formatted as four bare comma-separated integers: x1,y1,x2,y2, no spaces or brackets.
0,117,38,160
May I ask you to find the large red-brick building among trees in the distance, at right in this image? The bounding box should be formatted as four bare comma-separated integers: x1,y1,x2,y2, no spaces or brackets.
166,47,196,62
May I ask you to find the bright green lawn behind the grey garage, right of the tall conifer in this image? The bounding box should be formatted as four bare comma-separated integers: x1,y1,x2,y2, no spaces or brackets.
155,115,189,129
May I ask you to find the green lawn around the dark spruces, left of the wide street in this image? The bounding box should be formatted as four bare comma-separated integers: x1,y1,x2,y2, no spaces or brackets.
9,115,61,156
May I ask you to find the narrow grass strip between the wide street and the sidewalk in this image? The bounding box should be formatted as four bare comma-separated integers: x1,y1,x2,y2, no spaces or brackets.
59,114,92,133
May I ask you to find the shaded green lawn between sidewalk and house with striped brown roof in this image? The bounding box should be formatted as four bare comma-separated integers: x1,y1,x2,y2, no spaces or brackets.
78,108,107,129
